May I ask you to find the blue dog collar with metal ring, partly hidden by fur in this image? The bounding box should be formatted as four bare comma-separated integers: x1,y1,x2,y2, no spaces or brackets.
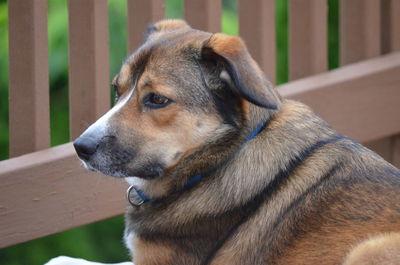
126,118,268,207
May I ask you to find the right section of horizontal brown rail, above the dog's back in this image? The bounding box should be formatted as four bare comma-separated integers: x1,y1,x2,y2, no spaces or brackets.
278,52,400,142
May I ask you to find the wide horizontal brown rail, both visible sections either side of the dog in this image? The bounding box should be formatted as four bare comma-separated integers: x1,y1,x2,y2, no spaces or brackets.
0,53,400,247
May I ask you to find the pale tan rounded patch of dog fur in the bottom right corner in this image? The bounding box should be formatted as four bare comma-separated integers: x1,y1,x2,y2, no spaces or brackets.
343,233,400,265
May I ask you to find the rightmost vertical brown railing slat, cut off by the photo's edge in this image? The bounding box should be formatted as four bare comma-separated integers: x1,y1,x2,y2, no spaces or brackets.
381,0,400,168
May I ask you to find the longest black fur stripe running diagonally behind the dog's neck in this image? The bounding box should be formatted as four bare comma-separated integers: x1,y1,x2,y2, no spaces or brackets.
202,135,345,265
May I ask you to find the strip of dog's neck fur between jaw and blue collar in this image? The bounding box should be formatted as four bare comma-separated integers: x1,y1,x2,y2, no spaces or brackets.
126,100,279,201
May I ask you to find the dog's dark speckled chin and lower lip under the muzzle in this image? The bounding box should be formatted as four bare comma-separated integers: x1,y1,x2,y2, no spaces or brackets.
81,160,164,180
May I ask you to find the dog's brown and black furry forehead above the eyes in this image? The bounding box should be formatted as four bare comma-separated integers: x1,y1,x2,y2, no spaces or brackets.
117,30,211,102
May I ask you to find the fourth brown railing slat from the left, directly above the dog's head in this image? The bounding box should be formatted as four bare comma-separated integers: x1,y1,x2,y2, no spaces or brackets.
184,0,222,32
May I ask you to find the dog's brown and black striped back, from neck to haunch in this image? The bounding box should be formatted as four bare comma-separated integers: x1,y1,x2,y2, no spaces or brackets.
203,101,400,264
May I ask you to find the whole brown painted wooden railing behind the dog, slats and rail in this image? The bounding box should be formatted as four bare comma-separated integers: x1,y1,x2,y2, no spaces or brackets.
0,0,400,247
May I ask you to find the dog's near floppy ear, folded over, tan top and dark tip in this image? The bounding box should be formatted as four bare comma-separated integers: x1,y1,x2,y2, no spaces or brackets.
201,33,279,109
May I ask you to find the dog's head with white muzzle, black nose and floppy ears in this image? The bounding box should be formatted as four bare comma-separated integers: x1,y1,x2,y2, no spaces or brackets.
74,20,279,183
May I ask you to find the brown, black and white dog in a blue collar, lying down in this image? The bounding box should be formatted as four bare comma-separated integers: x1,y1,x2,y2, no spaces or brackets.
49,20,400,265
